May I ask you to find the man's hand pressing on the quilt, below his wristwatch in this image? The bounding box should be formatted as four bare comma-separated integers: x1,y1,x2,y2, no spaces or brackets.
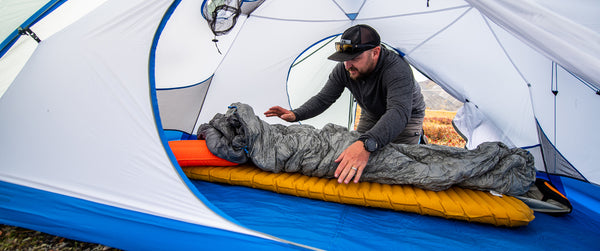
334,141,371,184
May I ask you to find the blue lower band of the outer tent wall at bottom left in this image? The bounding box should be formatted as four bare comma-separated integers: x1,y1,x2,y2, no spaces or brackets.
0,182,299,250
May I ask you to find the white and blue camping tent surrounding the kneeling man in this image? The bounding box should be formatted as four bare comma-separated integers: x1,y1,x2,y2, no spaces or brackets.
0,0,600,250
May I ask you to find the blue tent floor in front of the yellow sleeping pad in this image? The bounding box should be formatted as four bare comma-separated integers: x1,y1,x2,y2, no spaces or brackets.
192,177,600,250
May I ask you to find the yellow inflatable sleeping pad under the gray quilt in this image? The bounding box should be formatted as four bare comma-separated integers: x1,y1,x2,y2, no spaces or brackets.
182,165,535,227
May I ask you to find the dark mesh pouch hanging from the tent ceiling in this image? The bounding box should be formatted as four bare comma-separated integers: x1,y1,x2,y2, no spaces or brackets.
202,0,242,53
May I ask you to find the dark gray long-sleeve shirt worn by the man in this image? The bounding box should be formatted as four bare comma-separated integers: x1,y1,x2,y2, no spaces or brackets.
293,47,425,148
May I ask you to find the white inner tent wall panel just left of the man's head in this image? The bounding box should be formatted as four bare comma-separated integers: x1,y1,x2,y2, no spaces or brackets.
192,1,348,125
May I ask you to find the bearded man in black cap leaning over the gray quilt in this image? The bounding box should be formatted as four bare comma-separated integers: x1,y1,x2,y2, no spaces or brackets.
265,25,425,183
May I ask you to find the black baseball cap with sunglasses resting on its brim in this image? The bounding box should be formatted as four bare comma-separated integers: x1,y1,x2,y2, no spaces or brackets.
327,24,381,62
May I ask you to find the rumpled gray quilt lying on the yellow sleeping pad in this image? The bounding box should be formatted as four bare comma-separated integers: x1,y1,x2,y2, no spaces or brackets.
198,103,536,195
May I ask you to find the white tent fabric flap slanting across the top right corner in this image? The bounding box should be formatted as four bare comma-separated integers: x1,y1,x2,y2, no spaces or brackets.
468,0,600,88
